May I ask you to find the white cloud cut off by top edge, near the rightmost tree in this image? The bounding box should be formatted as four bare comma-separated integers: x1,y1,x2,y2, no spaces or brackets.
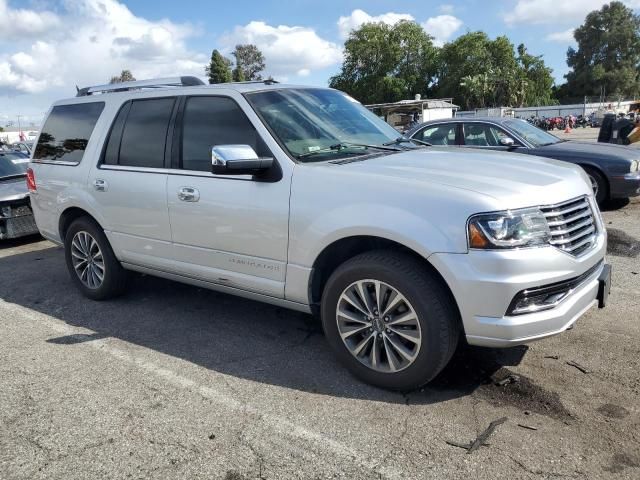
504,0,640,25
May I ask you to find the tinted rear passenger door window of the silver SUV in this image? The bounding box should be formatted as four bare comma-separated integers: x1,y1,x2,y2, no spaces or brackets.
119,98,175,168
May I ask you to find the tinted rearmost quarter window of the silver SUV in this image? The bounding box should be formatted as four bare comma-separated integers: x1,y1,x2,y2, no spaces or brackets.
33,102,104,164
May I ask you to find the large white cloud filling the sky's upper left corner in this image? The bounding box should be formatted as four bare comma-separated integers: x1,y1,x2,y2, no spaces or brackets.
0,0,206,95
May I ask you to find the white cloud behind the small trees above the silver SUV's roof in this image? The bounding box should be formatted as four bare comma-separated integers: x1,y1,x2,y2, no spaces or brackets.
221,21,342,79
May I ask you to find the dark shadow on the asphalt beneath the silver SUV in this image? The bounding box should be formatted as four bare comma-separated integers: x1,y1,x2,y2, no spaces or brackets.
0,247,526,404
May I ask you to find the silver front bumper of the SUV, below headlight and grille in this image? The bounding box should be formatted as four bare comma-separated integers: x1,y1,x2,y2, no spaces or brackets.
429,234,606,347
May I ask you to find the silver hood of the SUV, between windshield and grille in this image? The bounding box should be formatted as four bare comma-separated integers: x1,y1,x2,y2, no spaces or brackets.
328,147,591,208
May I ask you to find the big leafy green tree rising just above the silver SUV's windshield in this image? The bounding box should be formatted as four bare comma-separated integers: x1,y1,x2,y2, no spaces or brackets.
329,21,437,103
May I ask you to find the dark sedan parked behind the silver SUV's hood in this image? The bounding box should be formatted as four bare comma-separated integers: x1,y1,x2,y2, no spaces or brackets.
407,118,640,205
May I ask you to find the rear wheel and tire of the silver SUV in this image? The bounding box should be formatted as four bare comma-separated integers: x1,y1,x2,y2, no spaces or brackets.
64,217,127,300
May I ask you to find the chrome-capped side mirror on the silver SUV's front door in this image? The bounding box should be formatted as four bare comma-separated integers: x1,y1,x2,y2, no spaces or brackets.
211,145,273,175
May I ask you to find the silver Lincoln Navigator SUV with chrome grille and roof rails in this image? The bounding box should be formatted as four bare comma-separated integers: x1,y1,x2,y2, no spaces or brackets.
27,77,610,389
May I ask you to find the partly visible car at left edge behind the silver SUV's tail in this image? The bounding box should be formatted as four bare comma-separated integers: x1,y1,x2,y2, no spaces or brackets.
0,150,38,240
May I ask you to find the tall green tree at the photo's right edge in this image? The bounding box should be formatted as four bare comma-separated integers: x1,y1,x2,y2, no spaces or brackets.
564,2,640,96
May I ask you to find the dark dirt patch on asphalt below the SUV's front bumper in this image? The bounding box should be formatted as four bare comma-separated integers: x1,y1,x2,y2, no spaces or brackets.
478,368,574,420
